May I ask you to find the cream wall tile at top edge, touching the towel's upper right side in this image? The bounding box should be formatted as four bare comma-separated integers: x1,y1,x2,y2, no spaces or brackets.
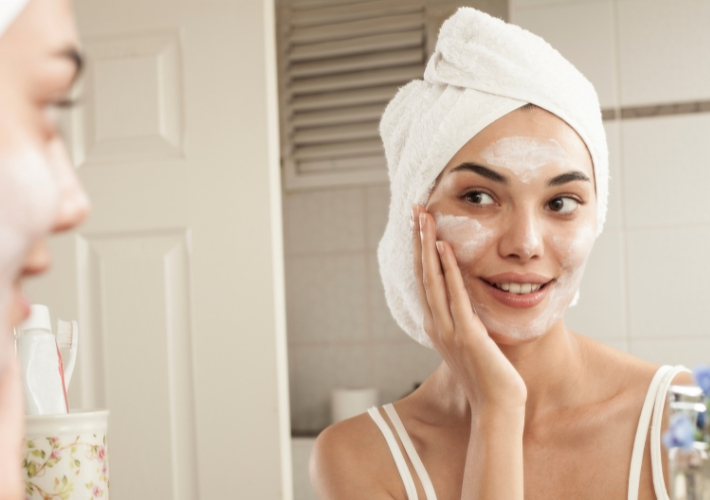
514,0,618,108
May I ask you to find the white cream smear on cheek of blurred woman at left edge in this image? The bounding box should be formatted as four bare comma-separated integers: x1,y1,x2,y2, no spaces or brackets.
0,148,59,376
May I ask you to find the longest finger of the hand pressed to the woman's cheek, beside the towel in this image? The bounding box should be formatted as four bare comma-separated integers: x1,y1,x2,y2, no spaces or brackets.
419,212,453,335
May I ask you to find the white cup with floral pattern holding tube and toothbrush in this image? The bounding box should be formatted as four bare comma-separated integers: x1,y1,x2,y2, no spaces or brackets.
22,410,109,500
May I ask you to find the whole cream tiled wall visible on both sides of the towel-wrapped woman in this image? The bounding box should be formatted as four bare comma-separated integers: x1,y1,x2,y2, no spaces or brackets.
284,0,710,430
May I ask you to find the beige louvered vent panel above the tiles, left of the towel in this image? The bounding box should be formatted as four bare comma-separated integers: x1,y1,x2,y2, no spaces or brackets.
280,0,425,188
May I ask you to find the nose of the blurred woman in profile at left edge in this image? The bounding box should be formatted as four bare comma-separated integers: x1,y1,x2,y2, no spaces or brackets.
49,139,91,233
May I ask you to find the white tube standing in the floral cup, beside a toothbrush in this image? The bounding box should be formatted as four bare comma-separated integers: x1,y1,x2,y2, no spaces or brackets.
16,304,69,415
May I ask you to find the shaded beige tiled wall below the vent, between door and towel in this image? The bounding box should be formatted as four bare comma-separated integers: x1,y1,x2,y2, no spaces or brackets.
284,186,441,431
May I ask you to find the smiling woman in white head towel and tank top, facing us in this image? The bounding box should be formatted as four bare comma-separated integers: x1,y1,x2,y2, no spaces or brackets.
311,9,691,500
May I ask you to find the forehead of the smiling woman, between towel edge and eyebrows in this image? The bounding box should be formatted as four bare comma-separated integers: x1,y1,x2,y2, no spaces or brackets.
445,108,594,179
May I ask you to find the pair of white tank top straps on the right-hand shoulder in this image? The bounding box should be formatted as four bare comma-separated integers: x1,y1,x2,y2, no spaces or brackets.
628,365,688,500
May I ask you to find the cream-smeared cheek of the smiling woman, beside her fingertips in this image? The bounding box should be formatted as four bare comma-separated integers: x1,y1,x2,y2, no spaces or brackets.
434,213,494,267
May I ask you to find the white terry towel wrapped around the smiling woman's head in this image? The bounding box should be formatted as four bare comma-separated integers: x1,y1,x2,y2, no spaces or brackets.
377,7,609,347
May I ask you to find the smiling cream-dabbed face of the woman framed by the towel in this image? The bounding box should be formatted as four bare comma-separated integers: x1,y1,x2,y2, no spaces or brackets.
426,108,597,344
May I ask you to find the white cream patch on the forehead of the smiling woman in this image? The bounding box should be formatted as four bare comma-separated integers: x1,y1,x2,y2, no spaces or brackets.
481,137,569,184
